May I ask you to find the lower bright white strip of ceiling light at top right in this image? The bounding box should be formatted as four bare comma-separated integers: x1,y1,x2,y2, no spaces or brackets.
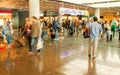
87,2,120,8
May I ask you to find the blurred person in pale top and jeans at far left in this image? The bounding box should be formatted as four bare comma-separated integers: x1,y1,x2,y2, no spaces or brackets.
2,18,13,48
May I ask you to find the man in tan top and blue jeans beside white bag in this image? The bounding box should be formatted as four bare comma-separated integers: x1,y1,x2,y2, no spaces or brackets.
29,16,40,55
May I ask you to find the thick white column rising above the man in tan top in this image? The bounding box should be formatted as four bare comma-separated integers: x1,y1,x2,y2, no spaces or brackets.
29,0,40,18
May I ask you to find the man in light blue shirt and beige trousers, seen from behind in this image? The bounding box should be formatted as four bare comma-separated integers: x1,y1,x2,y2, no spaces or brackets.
88,17,103,58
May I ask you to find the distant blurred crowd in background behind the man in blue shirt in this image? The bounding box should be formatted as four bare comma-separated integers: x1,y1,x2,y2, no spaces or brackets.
19,17,120,41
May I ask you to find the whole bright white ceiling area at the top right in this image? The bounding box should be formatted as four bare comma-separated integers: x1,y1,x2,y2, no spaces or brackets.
60,0,120,8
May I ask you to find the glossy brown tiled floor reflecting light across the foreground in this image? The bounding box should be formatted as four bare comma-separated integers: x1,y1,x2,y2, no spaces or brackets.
0,33,120,75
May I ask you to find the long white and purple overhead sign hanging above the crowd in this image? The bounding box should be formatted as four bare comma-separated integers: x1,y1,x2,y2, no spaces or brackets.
59,8,89,16
